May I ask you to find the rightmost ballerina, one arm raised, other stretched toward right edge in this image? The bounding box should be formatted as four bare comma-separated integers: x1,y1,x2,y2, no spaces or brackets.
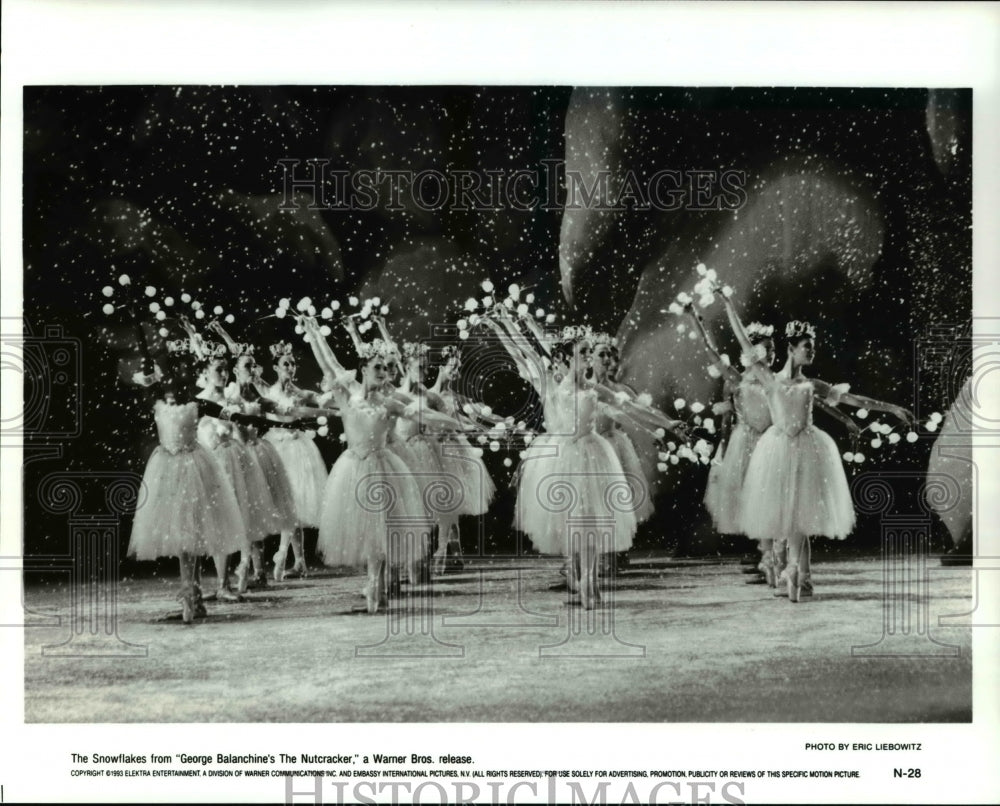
715,289,912,602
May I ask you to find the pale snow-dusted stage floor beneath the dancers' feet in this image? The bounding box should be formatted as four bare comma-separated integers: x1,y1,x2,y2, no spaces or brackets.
24,554,972,723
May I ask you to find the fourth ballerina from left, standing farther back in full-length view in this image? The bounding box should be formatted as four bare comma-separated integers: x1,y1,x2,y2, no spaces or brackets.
263,341,327,581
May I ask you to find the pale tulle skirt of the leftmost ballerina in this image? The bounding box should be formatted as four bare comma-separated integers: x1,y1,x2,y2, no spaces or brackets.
128,445,247,560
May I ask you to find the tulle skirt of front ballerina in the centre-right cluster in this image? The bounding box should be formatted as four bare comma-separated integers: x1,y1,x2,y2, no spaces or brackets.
515,434,638,555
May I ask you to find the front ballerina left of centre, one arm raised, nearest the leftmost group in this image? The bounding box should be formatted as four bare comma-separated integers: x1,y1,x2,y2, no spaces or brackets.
301,317,459,613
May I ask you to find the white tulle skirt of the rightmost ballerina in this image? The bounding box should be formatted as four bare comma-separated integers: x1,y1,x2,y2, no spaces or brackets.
739,425,854,540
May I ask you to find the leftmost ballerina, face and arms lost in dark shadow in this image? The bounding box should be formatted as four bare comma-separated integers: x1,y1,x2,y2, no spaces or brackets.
127,336,246,624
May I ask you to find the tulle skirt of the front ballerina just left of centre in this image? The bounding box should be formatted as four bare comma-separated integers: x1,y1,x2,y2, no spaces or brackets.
316,449,429,565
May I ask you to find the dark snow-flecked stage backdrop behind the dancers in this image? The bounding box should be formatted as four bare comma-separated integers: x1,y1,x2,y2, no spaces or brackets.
24,86,972,572
